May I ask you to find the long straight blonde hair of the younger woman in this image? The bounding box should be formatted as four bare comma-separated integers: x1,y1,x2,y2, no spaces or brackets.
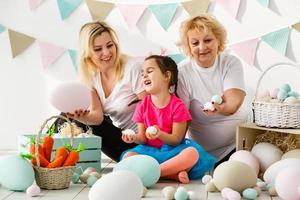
79,21,126,87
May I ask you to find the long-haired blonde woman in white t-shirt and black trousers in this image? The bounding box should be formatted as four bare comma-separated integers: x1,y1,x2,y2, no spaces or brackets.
67,21,145,161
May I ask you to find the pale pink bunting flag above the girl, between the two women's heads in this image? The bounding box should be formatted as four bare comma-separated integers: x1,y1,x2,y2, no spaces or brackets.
117,4,147,28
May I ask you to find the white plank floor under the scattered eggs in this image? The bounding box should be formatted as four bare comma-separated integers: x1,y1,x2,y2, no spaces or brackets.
0,152,280,200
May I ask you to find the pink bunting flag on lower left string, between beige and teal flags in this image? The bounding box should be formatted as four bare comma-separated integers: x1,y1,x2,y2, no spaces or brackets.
38,41,66,68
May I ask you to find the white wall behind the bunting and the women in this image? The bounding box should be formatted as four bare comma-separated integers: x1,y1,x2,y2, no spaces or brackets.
0,0,300,150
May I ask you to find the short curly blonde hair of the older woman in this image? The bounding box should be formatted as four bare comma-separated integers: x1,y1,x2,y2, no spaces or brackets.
179,14,227,56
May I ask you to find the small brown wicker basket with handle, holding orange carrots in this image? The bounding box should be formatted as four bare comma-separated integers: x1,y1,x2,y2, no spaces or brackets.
34,115,75,190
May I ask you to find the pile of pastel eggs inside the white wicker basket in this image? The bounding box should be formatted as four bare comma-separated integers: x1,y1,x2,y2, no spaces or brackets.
257,83,300,104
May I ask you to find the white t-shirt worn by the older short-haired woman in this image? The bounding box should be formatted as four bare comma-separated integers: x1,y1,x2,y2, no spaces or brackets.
177,53,248,160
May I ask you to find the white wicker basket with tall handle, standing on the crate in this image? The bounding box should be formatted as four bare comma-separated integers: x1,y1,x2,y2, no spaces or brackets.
252,63,300,128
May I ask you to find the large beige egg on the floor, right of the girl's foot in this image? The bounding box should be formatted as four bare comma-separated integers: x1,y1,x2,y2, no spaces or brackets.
213,160,257,192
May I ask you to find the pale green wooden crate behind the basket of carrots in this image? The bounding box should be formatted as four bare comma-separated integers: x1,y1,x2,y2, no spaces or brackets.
18,134,101,174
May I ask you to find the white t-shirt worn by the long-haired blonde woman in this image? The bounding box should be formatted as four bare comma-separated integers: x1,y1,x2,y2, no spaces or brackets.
93,57,144,131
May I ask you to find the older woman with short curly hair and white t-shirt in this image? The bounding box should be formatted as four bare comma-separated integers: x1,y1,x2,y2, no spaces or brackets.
177,15,247,162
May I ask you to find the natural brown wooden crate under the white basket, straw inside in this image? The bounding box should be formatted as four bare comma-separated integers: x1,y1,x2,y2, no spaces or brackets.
236,123,300,150
